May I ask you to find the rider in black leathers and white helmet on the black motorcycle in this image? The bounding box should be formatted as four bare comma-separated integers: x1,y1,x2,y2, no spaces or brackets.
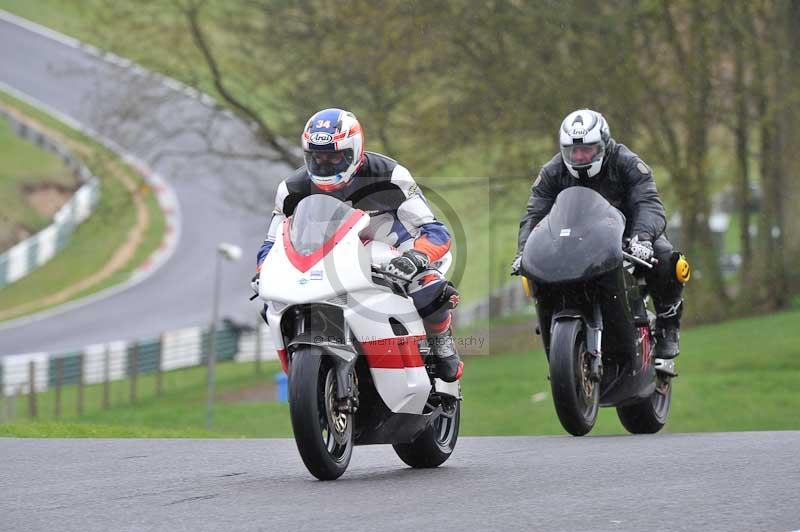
512,109,688,359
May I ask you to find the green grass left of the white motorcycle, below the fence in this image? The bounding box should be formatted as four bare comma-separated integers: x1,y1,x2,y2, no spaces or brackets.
0,361,291,437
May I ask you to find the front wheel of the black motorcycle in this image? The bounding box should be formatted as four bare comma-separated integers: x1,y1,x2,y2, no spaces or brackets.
550,318,600,436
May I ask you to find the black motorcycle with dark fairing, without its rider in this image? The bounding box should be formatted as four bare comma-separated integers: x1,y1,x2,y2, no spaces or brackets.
521,187,676,436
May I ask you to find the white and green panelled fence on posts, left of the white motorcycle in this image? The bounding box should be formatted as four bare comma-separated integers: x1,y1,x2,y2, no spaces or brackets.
0,319,278,420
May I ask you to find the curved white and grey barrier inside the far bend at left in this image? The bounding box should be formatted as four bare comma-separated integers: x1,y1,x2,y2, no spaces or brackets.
0,108,100,289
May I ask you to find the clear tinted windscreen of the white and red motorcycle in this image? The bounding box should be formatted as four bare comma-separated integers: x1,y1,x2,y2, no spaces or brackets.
289,194,357,257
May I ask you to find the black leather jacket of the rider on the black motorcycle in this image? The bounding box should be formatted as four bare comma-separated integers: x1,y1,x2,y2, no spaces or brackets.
517,139,667,252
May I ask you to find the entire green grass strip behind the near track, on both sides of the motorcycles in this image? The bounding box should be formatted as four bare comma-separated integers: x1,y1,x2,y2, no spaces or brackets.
0,310,800,437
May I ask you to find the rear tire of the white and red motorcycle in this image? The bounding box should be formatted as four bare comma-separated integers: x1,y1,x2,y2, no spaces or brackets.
392,401,461,469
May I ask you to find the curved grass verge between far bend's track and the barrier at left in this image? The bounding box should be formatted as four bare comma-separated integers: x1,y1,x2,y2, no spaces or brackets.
0,93,166,317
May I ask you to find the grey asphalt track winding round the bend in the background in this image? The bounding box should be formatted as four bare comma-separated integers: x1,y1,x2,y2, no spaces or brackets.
0,14,288,355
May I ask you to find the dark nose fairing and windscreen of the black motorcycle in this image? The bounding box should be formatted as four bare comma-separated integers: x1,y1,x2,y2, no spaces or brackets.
522,187,625,283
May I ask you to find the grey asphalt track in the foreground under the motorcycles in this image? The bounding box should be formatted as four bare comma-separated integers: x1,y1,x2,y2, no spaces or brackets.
0,432,800,532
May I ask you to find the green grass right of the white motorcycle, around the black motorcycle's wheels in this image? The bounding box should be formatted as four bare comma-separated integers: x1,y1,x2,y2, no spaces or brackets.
463,311,800,435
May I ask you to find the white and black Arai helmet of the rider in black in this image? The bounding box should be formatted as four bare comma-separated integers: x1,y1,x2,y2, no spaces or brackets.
559,109,610,178
